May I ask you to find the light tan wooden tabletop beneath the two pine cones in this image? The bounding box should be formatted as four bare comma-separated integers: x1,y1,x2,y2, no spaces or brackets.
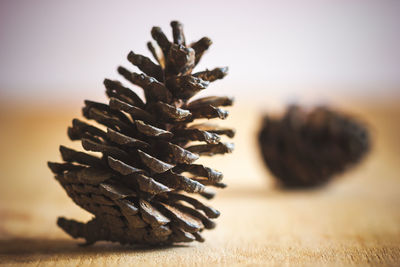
0,99,400,266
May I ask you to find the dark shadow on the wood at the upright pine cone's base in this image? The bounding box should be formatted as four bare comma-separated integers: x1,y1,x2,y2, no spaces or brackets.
0,238,185,263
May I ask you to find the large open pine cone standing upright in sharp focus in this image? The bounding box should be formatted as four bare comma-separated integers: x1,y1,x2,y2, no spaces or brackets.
48,21,234,245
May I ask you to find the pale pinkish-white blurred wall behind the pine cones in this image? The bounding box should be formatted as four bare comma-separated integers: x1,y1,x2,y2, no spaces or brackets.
0,0,400,104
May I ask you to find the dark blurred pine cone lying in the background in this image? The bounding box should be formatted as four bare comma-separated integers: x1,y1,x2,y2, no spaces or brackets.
258,106,370,187
